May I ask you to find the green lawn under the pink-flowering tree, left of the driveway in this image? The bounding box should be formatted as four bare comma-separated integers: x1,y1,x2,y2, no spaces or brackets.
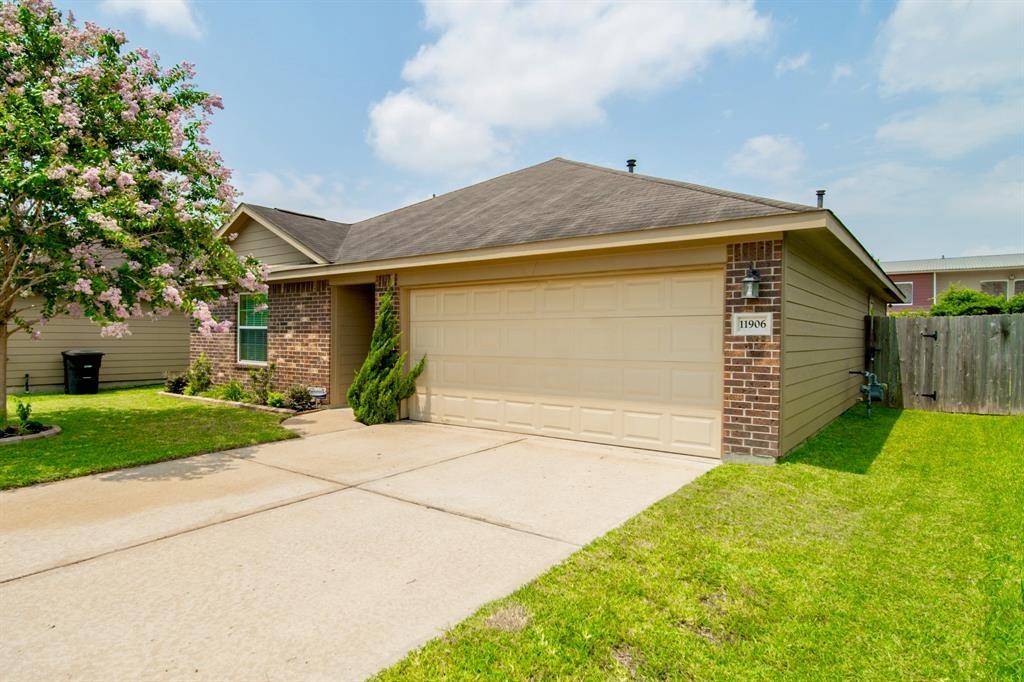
0,386,295,489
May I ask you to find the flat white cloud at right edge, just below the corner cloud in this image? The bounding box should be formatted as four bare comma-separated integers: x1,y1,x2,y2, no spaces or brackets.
877,97,1024,159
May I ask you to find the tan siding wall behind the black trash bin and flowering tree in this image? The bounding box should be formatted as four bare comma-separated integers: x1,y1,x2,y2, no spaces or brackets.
7,301,188,390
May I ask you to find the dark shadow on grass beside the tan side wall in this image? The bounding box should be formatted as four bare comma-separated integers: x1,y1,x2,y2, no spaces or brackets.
782,403,902,474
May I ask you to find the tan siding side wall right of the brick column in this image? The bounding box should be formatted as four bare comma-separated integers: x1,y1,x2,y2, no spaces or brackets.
782,237,868,453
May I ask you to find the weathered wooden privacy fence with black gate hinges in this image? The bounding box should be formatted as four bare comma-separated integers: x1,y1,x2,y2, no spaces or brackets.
865,314,1024,415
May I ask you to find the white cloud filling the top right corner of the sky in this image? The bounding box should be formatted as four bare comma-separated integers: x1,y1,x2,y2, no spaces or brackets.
881,0,1024,94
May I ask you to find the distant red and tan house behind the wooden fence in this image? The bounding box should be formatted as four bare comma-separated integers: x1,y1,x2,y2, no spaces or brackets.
881,253,1024,310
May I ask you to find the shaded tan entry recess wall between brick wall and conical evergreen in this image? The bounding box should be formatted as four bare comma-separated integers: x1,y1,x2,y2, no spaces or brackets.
331,286,374,404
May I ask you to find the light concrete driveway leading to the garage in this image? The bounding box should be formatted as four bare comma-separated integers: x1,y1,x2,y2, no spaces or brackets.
0,411,714,681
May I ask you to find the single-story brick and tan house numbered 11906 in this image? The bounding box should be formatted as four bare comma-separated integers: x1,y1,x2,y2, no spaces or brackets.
191,159,900,461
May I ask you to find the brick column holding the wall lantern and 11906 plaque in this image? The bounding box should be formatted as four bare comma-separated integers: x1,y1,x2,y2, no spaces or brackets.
722,240,782,463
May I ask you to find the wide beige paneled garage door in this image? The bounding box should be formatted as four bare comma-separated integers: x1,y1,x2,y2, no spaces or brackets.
410,270,723,457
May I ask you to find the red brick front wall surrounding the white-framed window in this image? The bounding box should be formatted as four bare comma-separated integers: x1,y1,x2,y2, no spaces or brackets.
188,280,331,399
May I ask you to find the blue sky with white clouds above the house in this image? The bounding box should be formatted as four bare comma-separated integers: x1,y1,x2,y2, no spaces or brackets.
58,0,1024,259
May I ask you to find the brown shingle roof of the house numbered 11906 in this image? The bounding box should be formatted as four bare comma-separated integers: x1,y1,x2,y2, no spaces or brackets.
230,159,820,264
